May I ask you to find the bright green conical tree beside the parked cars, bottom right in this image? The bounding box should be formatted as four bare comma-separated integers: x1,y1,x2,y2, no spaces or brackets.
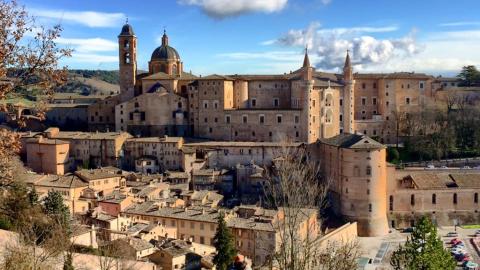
390,216,456,270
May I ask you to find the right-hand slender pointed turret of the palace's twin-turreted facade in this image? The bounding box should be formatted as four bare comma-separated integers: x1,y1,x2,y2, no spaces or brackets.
342,51,355,134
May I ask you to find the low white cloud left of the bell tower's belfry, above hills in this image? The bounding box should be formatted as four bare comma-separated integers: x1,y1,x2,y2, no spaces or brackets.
56,37,118,53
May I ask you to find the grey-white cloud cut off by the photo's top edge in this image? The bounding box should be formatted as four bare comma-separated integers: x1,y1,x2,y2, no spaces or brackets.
177,0,288,19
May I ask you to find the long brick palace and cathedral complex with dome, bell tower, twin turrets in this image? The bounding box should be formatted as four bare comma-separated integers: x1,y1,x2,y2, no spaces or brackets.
84,24,457,144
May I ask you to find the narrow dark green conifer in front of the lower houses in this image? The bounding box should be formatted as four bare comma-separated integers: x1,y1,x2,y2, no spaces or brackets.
213,212,237,270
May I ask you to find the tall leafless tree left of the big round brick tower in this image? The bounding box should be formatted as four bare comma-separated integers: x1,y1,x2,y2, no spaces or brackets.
258,148,357,270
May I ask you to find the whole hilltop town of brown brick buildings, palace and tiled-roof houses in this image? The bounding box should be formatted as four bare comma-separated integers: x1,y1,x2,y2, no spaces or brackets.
0,4,480,269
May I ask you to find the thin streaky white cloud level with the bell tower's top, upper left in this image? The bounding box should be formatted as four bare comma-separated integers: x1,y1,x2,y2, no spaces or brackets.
29,9,126,27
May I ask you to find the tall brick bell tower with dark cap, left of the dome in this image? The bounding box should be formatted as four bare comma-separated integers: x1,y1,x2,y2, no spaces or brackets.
118,19,137,101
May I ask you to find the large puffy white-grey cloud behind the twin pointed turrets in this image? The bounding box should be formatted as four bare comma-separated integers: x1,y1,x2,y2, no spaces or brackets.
276,23,421,70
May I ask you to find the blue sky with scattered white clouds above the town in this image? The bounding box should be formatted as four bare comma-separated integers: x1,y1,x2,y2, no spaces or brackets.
21,0,480,75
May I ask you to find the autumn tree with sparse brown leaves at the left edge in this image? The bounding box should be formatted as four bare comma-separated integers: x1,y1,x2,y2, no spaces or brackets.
0,0,72,185
